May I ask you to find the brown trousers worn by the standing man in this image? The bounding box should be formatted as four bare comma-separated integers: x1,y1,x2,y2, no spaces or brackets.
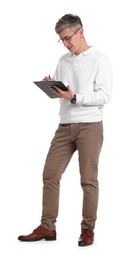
41,122,103,230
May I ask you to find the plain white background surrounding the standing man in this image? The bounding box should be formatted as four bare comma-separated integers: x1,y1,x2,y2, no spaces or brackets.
0,0,136,260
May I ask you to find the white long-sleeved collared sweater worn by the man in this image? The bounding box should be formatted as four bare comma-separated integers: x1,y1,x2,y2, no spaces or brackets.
54,47,112,124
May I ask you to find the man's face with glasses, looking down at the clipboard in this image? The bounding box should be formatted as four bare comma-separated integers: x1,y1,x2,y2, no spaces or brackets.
59,28,83,55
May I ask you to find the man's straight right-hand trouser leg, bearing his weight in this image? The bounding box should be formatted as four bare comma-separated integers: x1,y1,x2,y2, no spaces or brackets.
77,122,103,230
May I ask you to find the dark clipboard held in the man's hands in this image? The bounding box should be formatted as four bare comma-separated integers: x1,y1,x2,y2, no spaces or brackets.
33,80,67,98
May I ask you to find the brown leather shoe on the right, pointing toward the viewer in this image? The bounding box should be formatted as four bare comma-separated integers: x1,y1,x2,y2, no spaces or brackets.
78,228,94,246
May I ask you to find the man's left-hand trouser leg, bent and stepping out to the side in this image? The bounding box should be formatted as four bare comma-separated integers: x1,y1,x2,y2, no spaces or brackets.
41,125,76,230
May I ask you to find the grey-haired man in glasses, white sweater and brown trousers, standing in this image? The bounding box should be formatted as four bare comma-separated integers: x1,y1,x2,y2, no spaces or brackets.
18,14,112,246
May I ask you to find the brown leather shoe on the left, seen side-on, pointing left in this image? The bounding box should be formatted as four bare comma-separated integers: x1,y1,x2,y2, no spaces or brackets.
18,226,56,242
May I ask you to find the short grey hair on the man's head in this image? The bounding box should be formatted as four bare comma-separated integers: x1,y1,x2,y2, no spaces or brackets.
55,14,83,34
